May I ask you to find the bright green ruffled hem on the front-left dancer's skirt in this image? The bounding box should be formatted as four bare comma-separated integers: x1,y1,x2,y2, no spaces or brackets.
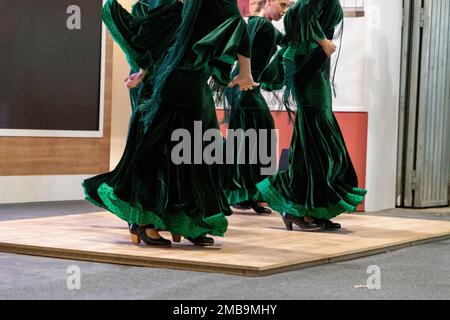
83,183,228,238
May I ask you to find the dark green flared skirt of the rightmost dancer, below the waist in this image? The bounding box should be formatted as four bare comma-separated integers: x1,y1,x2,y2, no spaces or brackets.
257,68,367,219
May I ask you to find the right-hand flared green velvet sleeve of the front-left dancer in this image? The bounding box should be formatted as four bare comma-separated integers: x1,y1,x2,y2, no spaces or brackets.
193,16,250,85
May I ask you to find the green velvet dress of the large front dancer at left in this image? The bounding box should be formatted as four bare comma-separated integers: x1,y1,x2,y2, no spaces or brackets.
83,0,250,238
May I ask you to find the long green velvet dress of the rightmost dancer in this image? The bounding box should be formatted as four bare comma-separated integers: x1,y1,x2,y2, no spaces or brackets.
258,0,366,219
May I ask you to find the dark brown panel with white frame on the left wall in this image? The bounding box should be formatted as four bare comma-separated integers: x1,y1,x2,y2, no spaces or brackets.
0,0,102,131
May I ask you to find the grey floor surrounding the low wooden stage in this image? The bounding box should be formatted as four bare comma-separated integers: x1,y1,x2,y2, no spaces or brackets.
0,201,450,300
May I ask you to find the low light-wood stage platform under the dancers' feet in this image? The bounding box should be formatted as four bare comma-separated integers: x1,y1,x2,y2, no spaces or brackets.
0,212,450,276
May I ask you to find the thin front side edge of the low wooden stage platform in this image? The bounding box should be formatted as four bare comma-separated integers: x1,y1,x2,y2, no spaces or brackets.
0,234,450,277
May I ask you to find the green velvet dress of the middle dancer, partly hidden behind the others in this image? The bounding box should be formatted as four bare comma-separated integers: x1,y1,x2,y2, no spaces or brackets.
225,16,283,205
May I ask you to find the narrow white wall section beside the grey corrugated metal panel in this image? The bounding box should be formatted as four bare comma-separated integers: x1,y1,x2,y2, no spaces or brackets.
365,0,402,211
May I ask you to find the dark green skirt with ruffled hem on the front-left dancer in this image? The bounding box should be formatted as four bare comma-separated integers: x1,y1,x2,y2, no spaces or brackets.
83,70,232,237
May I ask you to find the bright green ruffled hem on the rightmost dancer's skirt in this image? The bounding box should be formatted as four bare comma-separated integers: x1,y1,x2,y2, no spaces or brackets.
257,179,367,220
